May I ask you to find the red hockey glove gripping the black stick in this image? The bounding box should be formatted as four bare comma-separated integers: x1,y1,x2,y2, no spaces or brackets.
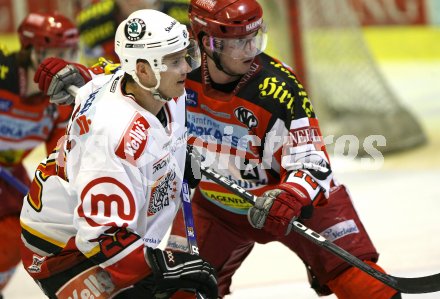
248,183,312,237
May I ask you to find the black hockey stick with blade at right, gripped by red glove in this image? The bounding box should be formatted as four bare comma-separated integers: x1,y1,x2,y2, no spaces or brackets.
201,164,440,294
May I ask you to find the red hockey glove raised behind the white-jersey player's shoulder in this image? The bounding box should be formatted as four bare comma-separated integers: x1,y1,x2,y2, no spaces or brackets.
34,57,92,105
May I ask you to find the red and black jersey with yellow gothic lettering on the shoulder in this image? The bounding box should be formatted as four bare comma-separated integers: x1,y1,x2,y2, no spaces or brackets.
186,53,332,214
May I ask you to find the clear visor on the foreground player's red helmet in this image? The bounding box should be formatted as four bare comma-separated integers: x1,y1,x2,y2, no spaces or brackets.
209,24,267,59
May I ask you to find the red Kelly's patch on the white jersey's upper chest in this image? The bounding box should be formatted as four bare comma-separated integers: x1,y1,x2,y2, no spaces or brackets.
115,113,150,164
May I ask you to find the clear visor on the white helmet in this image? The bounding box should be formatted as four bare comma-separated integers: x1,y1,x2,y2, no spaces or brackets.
161,39,201,72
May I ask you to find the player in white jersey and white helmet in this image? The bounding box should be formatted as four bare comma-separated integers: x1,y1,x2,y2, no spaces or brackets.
21,10,217,298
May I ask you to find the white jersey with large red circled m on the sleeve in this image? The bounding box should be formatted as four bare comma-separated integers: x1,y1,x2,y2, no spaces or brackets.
21,71,187,284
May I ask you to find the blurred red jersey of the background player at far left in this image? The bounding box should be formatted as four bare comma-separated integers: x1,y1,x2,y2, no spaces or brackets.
0,51,72,167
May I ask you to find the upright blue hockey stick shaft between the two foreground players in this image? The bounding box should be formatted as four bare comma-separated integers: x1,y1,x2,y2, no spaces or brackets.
180,179,205,299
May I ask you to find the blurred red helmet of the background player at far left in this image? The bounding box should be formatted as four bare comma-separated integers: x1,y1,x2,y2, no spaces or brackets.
18,13,79,50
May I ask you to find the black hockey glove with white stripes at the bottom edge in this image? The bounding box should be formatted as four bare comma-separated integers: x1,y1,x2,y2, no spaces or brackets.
147,247,218,299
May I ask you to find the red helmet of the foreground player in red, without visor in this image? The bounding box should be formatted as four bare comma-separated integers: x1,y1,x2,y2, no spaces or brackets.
189,0,263,38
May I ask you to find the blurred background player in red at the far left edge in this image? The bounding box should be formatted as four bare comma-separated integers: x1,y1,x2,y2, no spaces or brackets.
0,13,85,293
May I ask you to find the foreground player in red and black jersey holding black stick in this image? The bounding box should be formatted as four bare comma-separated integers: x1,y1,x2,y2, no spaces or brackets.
30,0,401,299
